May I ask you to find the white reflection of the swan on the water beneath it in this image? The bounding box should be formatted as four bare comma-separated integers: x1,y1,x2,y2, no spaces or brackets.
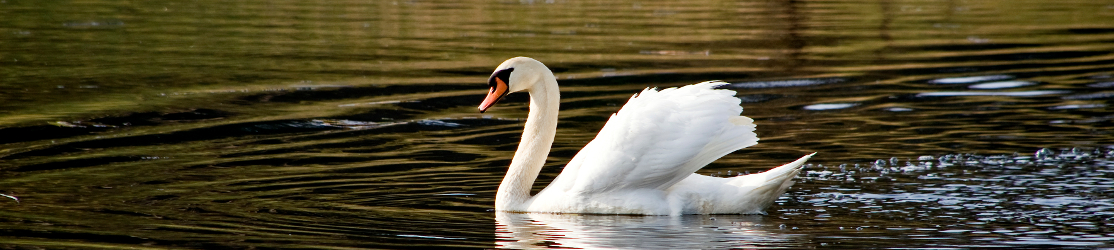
495,212,794,249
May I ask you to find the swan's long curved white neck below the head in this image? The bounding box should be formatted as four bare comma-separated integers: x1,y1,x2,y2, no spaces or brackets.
495,70,560,211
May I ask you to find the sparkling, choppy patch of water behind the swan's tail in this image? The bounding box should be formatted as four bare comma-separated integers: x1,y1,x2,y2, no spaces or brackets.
779,147,1114,248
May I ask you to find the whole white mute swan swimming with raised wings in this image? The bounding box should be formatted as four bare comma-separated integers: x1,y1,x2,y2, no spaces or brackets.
479,57,815,215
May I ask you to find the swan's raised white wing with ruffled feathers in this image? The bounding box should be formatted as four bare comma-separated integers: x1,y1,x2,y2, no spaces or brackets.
546,81,758,193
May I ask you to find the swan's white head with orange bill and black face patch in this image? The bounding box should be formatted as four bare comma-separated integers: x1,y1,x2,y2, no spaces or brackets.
480,57,553,113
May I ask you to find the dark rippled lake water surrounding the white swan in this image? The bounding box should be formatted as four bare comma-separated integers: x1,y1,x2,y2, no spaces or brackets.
0,0,1114,249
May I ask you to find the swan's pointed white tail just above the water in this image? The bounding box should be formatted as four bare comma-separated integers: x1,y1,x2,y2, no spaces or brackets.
727,153,817,212
